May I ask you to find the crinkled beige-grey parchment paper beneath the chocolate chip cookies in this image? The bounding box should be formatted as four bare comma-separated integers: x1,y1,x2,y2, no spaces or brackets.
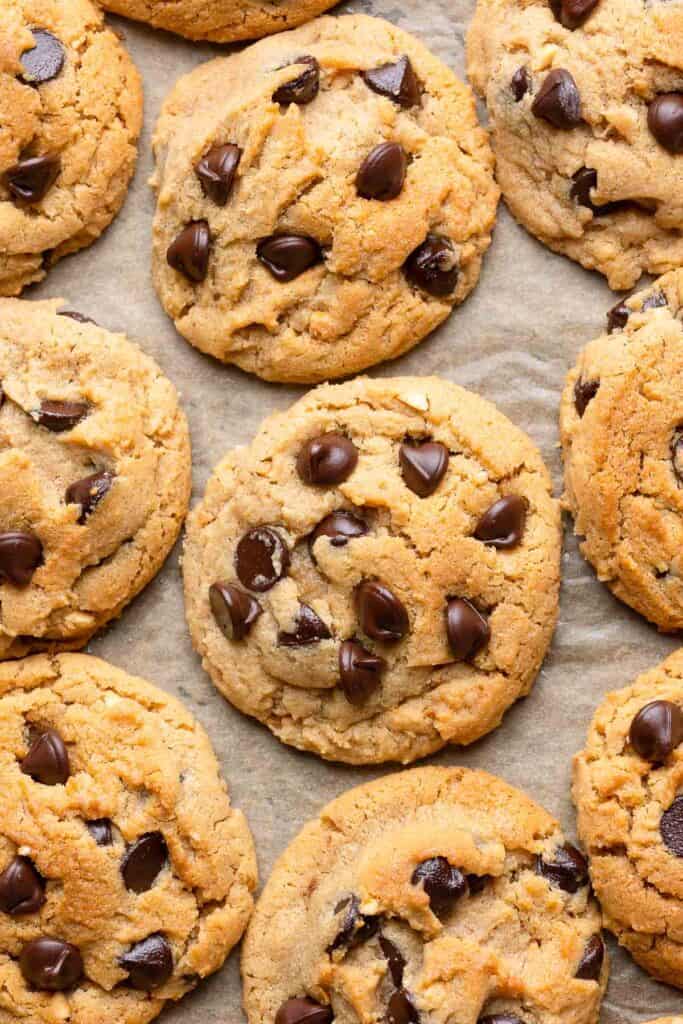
26,0,683,1024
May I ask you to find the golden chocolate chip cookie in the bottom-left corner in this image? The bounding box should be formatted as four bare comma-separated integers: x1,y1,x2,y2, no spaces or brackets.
0,654,256,1024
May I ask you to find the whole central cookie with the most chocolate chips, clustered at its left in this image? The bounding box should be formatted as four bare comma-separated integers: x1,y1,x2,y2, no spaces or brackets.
183,377,560,764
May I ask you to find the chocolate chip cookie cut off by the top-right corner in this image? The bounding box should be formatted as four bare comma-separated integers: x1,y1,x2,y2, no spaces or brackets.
468,0,683,289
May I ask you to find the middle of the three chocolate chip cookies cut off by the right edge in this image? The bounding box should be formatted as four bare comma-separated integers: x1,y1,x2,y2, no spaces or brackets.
560,270,683,631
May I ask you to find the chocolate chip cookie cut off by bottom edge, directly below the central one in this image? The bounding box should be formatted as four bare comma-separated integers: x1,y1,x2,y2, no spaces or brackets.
242,768,607,1024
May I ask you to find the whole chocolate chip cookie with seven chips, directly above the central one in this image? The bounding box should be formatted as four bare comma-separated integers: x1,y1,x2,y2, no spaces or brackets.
154,15,498,383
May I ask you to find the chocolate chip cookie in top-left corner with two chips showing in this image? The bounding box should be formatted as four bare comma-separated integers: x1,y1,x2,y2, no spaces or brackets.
0,0,142,295
